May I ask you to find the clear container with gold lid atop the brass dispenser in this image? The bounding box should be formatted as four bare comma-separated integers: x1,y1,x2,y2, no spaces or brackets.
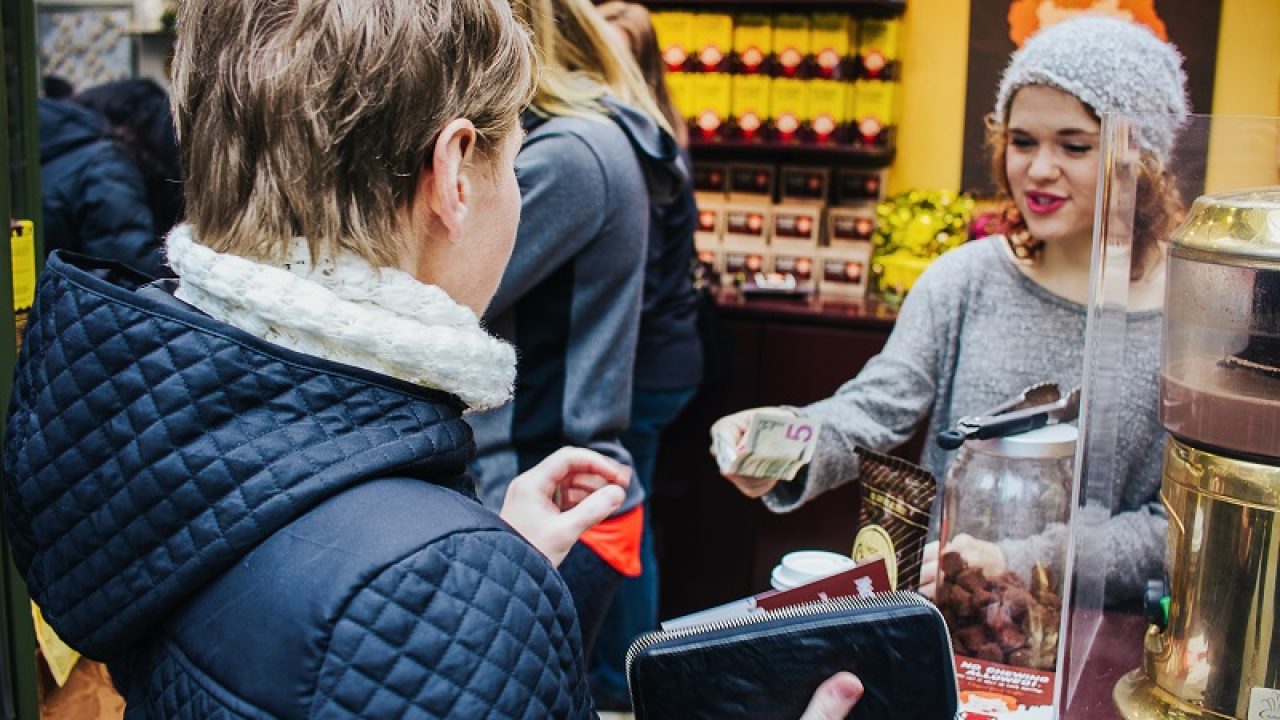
1160,187,1280,453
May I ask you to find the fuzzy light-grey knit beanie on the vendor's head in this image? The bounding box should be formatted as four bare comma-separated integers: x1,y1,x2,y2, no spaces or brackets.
996,15,1188,163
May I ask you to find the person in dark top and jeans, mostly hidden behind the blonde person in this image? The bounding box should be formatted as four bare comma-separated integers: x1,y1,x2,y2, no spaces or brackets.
590,1,703,710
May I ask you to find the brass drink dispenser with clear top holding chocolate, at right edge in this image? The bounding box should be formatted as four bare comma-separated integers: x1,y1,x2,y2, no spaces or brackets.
1115,187,1280,720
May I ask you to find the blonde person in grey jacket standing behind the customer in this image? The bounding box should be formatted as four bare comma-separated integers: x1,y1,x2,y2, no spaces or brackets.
472,0,687,655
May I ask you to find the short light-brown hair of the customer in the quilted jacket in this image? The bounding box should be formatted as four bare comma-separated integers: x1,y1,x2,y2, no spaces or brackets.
173,0,536,266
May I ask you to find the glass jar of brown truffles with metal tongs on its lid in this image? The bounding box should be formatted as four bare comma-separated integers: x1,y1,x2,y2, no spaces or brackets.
937,425,1078,671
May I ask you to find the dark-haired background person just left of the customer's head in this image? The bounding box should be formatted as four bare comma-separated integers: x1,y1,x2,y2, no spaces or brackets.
74,78,183,238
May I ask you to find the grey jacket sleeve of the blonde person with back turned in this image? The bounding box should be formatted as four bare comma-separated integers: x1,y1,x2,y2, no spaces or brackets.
486,129,611,316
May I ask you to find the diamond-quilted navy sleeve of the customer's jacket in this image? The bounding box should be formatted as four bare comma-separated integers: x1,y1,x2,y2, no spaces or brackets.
311,530,593,720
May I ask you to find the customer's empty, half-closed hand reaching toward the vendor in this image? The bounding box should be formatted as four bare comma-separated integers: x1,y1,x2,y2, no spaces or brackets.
502,447,631,566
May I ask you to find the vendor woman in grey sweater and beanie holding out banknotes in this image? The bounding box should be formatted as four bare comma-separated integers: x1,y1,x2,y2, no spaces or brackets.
712,15,1188,603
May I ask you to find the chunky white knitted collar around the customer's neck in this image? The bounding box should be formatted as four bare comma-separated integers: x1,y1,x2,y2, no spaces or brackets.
166,225,516,410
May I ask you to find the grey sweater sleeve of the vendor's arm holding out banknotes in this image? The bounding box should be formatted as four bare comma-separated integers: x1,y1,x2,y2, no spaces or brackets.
764,256,960,512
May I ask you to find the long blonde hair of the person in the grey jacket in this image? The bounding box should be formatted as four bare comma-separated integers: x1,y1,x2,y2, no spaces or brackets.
512,0,672,132
